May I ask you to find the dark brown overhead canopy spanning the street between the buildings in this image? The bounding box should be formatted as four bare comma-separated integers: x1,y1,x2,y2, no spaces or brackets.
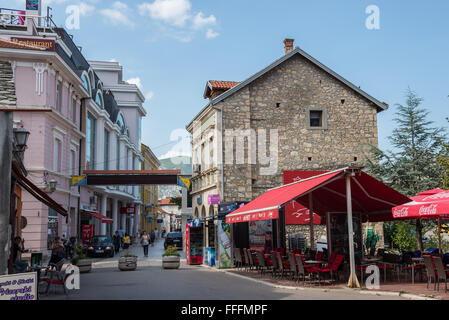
84,170,185,186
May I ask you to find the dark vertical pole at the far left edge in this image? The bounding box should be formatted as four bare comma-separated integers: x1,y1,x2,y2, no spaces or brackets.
0,111,13,275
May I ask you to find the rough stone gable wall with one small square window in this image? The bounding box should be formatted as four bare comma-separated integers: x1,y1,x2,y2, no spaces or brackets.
217,55,377,202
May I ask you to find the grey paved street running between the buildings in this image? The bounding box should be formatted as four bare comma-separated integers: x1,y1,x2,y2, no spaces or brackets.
41,240,402,300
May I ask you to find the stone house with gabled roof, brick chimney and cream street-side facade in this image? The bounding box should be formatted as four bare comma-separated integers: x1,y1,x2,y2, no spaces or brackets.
187,39,388,248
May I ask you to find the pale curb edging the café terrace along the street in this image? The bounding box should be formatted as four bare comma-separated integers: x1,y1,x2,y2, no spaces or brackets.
200,264,440,300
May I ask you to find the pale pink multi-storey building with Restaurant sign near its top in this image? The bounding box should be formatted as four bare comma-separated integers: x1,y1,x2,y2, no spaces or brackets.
0,1,146,253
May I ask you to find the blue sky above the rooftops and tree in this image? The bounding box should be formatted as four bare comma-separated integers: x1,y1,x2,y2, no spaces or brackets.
4,0,449,156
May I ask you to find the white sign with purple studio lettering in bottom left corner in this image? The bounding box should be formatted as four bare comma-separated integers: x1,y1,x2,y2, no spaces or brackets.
0,272,37,300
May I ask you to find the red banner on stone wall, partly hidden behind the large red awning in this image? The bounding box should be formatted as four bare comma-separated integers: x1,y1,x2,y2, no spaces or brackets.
284,171,327,225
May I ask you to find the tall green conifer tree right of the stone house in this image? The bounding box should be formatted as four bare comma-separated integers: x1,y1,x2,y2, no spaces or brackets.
366,88,445,251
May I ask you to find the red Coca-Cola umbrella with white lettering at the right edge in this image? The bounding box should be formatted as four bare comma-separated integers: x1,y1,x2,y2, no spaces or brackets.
391,189,449,252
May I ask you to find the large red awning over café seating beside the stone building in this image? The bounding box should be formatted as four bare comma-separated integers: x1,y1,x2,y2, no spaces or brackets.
226,168,410,223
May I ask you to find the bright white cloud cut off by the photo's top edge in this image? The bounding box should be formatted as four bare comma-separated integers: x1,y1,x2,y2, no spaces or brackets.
139,0,192,27
